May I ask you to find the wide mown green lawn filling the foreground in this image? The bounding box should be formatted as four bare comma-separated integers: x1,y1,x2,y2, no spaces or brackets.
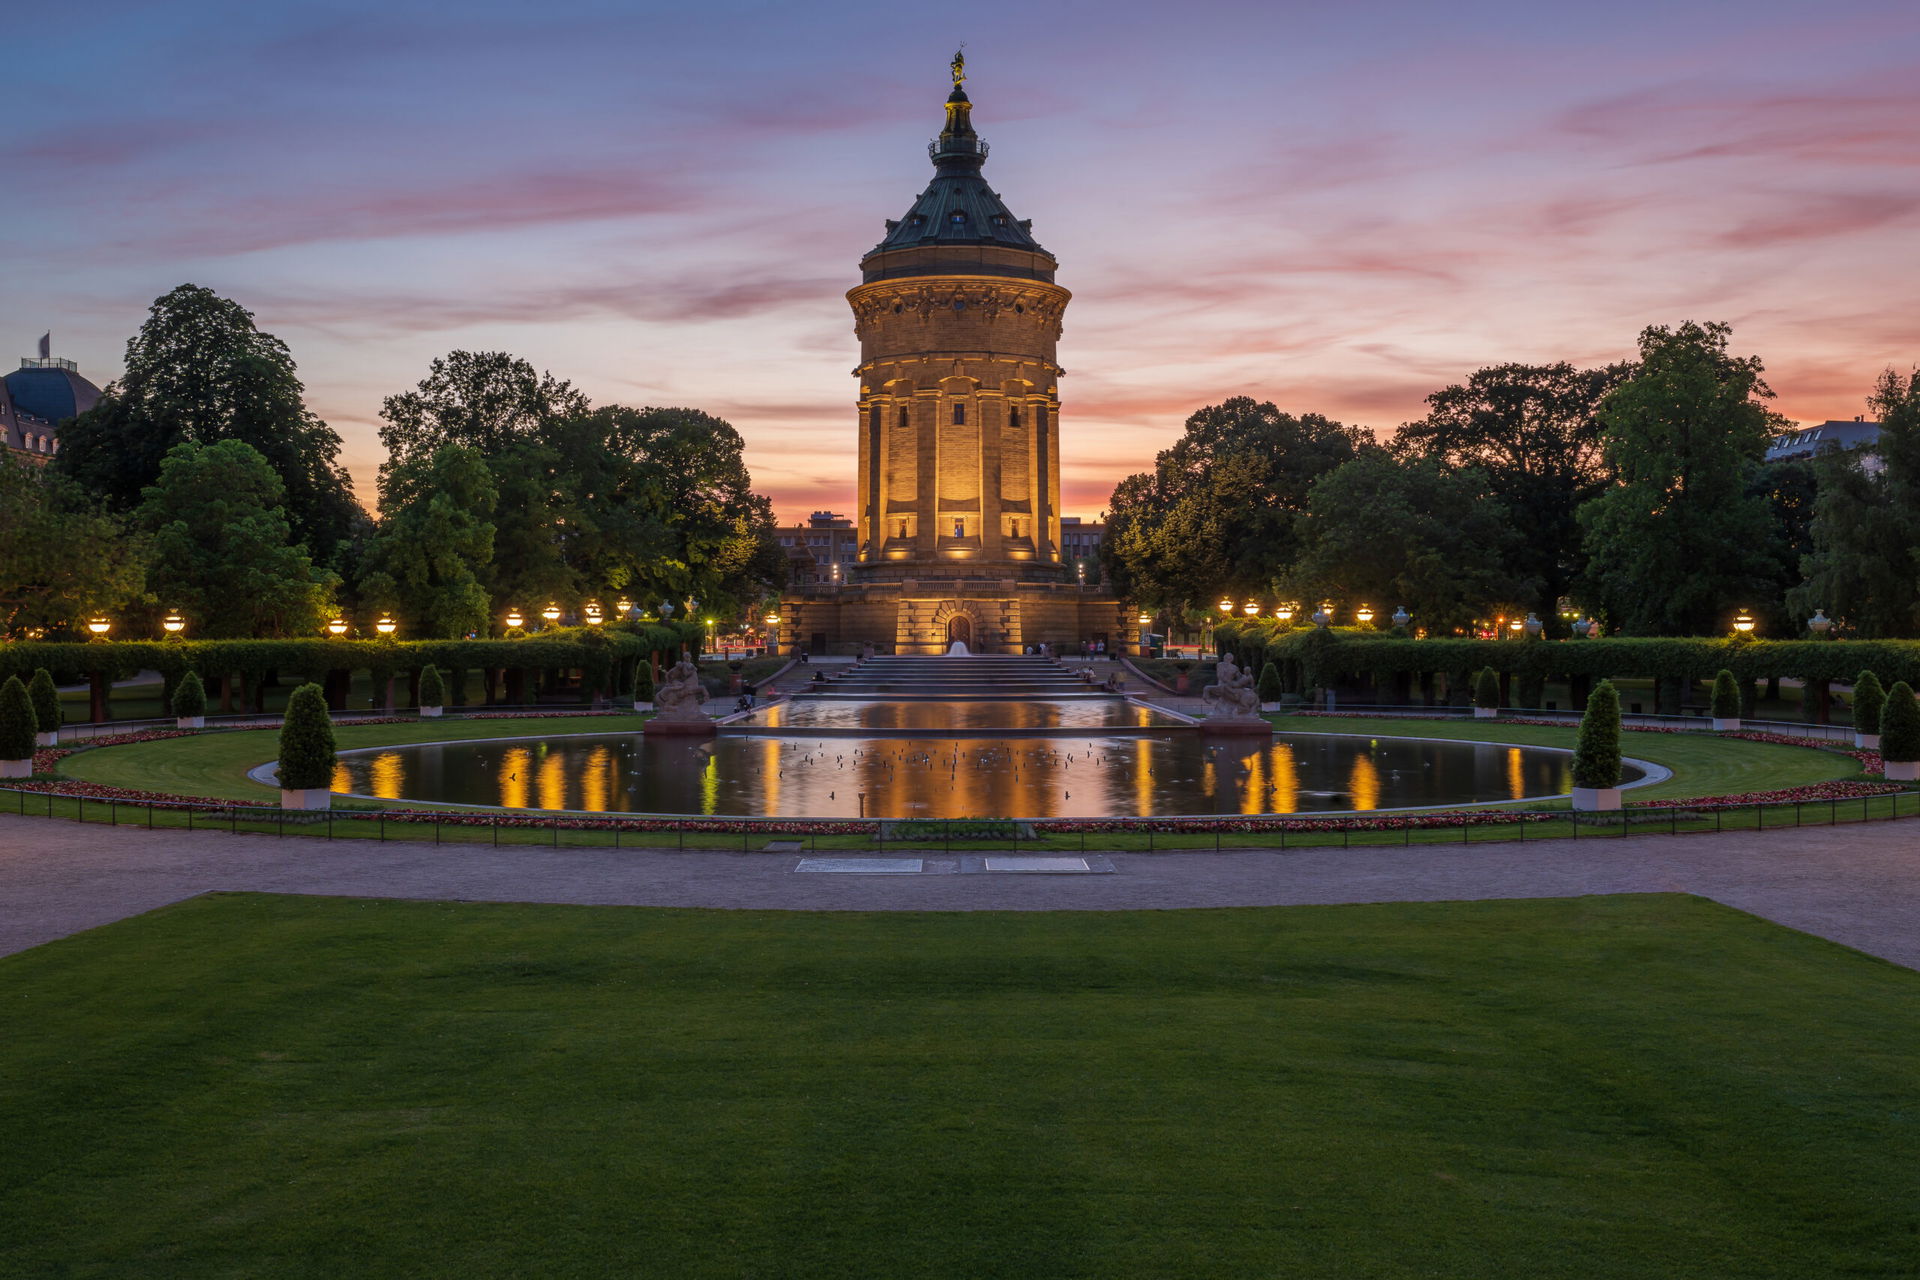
0,894,1920,1280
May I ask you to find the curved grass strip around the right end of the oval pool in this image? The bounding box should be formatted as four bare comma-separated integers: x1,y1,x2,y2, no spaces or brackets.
1269,716,1860,800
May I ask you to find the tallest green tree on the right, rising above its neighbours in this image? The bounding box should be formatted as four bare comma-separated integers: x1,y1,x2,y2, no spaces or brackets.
1578,320,1780,635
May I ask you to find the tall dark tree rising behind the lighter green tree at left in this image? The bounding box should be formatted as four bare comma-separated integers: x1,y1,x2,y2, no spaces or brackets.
54,284,357,562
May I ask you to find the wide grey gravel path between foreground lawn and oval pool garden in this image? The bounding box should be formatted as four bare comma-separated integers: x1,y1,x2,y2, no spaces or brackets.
0,816,1920,969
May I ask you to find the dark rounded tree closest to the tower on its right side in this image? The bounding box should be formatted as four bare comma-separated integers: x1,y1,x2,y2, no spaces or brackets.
1100,395,1373,610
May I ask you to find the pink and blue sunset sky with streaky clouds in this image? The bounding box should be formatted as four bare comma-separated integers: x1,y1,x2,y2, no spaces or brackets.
15,0,1920,518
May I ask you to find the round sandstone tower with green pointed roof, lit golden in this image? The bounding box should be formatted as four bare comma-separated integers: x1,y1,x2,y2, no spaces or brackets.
781,59,1127,652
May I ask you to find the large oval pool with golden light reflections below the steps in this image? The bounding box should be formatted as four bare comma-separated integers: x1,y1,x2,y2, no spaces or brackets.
334,729,1638,818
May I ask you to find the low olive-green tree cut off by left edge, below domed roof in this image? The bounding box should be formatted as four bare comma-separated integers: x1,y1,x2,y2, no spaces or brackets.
0,451,146,639
